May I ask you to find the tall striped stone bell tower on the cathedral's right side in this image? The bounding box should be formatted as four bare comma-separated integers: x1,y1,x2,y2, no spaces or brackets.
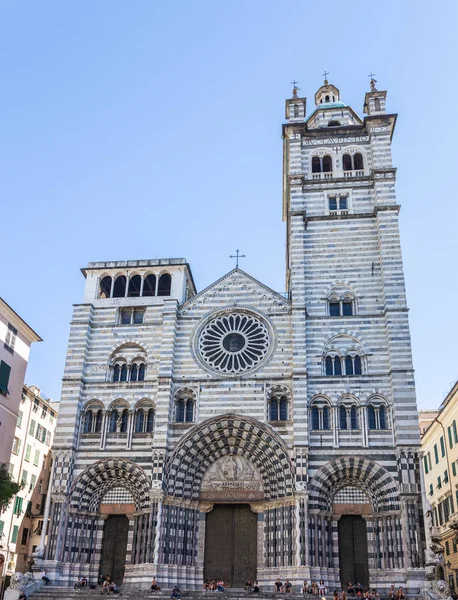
283,79,423,589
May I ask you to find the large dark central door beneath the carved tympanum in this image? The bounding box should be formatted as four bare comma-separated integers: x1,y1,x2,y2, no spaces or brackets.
204,504,257,587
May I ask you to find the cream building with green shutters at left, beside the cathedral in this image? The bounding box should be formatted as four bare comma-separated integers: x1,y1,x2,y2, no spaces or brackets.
0,385,58,577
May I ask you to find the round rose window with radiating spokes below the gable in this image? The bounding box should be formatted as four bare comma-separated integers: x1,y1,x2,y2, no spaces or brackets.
198,313,270,374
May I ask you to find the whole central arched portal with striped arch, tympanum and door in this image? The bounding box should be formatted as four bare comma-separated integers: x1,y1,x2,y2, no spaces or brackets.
162,413,294,587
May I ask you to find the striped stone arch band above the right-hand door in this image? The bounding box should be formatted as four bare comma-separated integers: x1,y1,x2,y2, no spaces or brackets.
309,456,400,512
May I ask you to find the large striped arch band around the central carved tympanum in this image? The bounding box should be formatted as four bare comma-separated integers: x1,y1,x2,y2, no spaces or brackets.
164,413,294,500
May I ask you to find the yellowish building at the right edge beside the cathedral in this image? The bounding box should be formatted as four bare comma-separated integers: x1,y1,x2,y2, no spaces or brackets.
421,381,458,590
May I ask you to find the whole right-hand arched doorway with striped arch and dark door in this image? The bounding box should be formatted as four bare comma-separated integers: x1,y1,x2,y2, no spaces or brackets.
309,456,404,589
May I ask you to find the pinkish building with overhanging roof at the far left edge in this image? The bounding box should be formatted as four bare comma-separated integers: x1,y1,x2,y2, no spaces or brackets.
0,298,42,464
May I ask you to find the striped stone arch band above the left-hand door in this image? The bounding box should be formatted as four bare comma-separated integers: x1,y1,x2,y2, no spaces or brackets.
70,458,150,511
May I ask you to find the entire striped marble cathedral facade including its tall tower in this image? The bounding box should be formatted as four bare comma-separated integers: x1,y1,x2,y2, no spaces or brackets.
44,80,424,593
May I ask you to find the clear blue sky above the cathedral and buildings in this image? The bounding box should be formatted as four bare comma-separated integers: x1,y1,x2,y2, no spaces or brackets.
0,0,458,407
